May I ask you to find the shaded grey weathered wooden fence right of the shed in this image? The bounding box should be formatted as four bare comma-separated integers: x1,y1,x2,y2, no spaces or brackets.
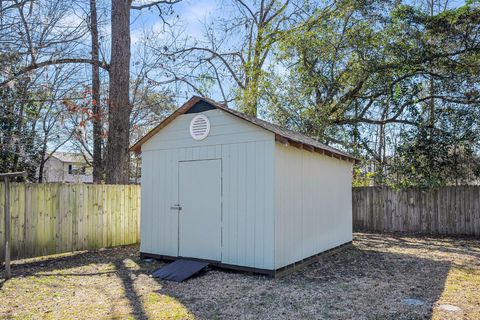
353,186,480,236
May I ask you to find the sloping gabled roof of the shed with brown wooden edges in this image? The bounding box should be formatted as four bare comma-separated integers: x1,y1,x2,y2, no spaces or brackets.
129,96,357,162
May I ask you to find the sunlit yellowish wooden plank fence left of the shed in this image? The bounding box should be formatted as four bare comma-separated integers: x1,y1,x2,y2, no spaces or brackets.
0,183,140,261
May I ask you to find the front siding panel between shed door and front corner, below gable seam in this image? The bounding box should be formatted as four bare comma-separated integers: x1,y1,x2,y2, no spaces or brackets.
222,140,274,269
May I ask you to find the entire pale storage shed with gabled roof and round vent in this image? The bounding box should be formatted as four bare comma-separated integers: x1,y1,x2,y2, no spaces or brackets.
130,97,355,276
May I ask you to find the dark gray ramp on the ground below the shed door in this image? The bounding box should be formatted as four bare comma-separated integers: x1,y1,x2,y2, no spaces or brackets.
152,259,208,282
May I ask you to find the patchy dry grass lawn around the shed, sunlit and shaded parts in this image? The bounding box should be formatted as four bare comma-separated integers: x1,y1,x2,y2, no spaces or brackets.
0,233,480,319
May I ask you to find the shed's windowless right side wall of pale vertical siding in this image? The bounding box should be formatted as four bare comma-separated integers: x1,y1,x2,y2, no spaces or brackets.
274,143,352,269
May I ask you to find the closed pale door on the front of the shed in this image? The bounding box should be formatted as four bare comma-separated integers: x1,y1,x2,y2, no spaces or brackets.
178,159,222,261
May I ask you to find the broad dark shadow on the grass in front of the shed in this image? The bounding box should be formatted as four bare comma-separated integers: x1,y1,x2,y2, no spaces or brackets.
153,241,458,319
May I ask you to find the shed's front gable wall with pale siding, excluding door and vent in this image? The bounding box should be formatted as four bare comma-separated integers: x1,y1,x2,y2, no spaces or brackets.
140,110,275,269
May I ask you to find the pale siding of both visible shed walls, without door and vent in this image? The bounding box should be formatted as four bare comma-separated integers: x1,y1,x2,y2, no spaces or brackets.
141,106,352,269
